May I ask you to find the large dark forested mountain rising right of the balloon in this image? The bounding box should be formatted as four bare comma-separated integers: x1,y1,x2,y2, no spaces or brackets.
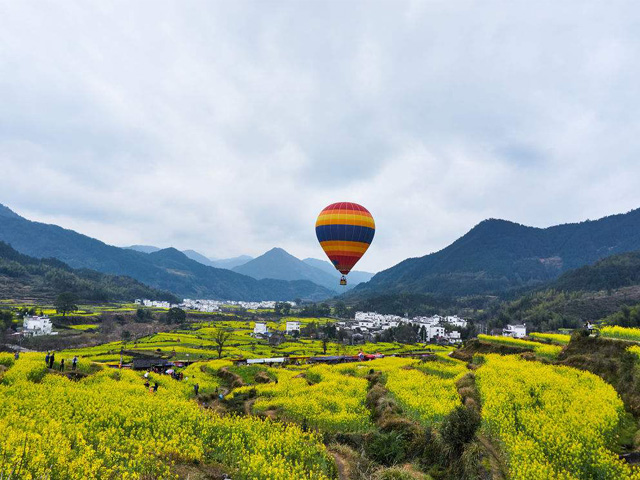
347,209,640,296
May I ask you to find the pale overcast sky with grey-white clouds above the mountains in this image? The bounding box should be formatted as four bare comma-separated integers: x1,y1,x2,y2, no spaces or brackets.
0,0,640,271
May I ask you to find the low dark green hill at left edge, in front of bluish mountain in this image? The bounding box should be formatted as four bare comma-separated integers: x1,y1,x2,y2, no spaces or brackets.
0,242,178,302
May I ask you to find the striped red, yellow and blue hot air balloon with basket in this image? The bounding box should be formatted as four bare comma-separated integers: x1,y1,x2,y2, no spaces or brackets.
316,202,376,285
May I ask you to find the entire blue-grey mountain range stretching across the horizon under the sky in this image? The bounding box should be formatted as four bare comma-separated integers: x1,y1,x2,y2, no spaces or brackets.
5,201,640,306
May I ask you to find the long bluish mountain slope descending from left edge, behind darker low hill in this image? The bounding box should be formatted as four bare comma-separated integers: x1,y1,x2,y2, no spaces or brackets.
0,205,332,300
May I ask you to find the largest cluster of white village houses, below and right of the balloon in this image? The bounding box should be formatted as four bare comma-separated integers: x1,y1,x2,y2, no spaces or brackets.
338,312,467,343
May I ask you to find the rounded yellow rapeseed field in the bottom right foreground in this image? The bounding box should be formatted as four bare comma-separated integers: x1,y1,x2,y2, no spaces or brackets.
476,355,640,480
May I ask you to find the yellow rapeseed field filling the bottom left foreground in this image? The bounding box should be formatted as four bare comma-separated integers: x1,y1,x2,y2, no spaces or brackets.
0,354,335,480
